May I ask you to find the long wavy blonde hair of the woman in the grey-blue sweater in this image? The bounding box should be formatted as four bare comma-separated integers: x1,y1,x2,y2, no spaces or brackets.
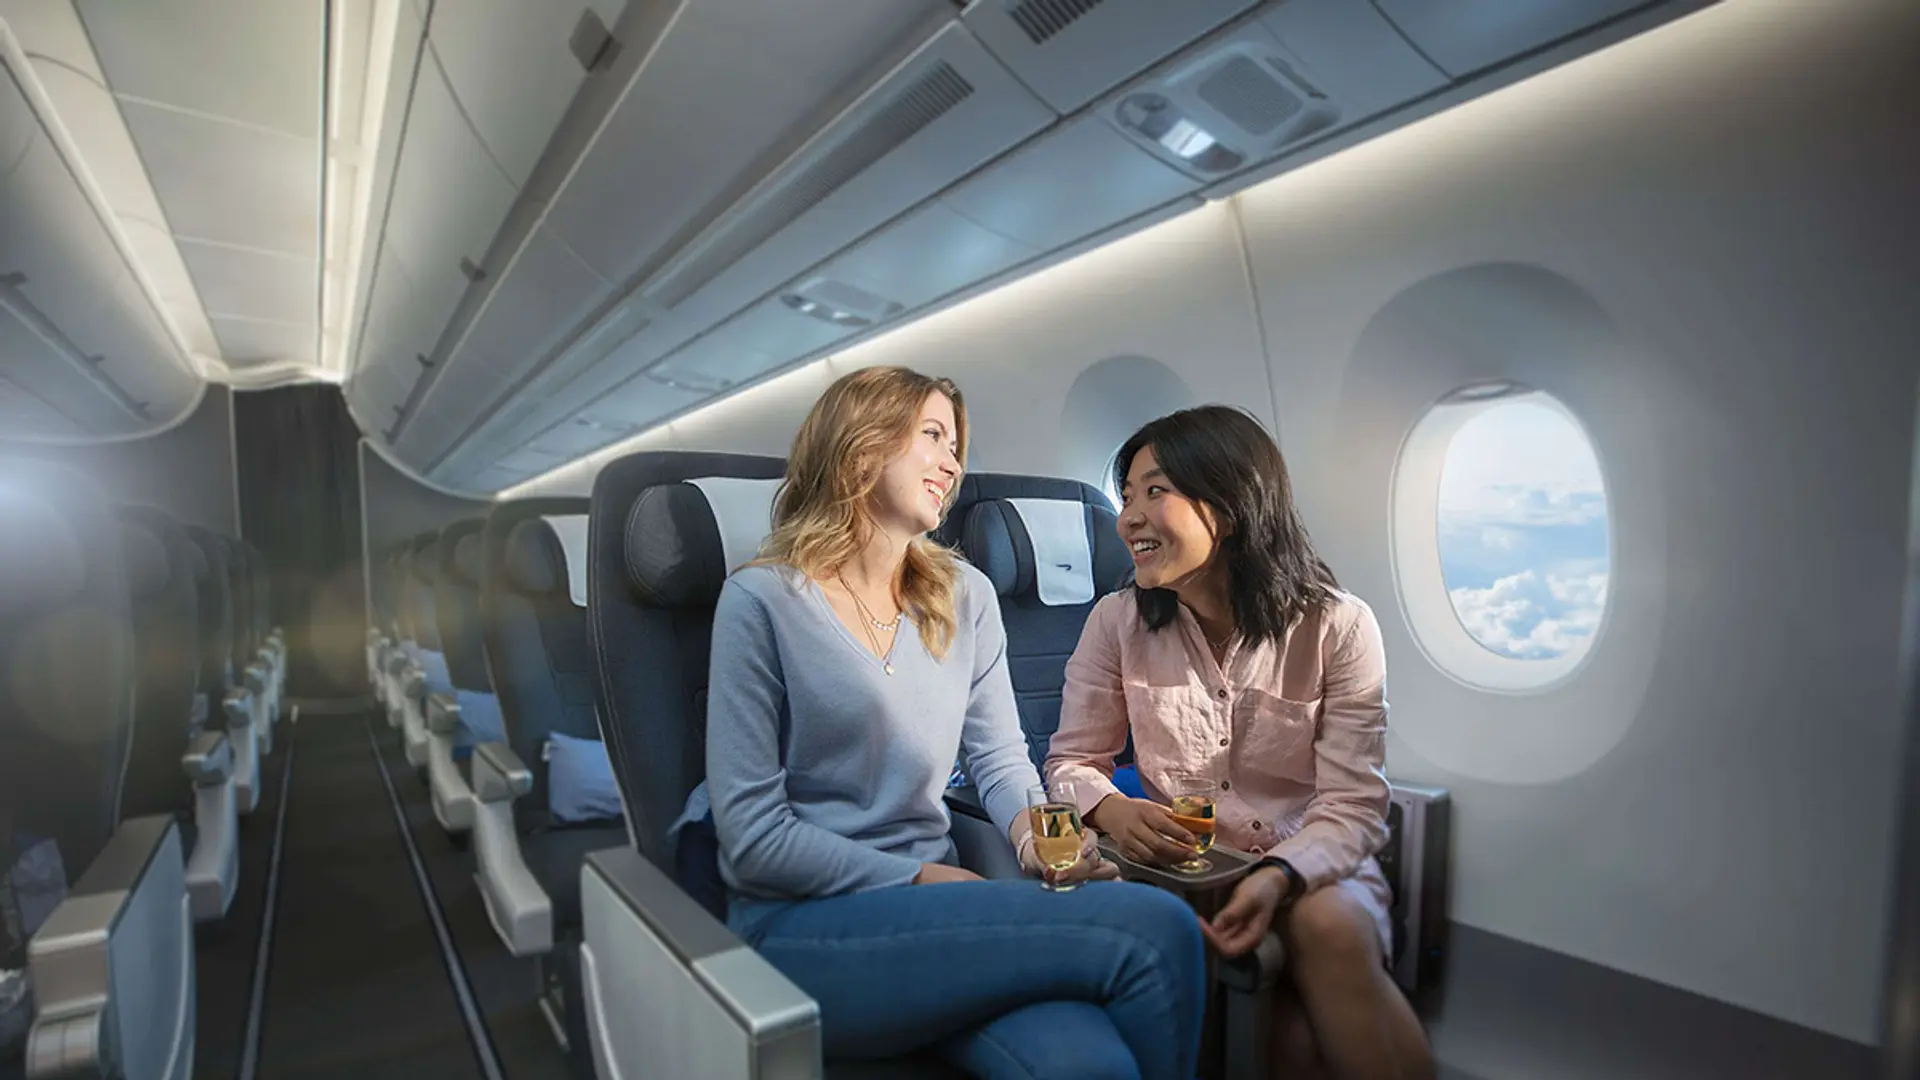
755,367,968,659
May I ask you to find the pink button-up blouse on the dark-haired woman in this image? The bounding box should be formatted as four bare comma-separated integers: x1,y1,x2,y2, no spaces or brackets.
1046,590,1388,890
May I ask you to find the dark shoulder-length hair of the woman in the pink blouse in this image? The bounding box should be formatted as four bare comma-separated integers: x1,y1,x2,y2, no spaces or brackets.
1114,405,1340,644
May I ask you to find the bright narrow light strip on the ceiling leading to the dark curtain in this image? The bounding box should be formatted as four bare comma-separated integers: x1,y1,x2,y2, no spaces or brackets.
321,0,405,380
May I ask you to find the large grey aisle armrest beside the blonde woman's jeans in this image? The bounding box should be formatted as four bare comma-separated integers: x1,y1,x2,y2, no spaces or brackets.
580,846,820,1076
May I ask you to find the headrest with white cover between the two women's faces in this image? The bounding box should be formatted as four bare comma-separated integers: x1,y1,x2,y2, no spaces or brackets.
962,498,1129,607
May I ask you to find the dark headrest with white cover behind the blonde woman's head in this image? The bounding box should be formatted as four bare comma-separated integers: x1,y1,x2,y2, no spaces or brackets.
626,477,783,607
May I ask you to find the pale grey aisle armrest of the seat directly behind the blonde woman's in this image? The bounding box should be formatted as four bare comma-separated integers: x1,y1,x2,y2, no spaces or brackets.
472,742,553,957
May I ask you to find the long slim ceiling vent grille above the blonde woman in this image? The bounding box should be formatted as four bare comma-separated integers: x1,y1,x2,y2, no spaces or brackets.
647,61,973,307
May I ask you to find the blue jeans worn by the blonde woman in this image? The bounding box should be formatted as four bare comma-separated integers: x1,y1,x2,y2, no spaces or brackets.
732,880,1206,1080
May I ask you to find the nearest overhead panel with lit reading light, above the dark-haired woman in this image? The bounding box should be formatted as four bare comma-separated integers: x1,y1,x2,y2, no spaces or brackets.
1098,0,1448,183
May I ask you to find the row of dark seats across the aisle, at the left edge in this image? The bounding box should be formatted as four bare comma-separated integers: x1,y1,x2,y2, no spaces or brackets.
0,459,286,1076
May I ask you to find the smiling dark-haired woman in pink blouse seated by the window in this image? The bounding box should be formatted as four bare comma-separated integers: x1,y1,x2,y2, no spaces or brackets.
1046,405,1434,1080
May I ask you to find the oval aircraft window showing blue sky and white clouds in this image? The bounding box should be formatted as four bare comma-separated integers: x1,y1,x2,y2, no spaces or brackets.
1402,384,1613,690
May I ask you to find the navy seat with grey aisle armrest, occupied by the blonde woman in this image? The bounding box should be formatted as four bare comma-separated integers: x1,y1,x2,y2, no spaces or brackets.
578,452,975,1078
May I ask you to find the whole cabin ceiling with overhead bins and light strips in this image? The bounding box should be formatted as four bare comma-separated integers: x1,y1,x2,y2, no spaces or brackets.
0,0,1709,457
